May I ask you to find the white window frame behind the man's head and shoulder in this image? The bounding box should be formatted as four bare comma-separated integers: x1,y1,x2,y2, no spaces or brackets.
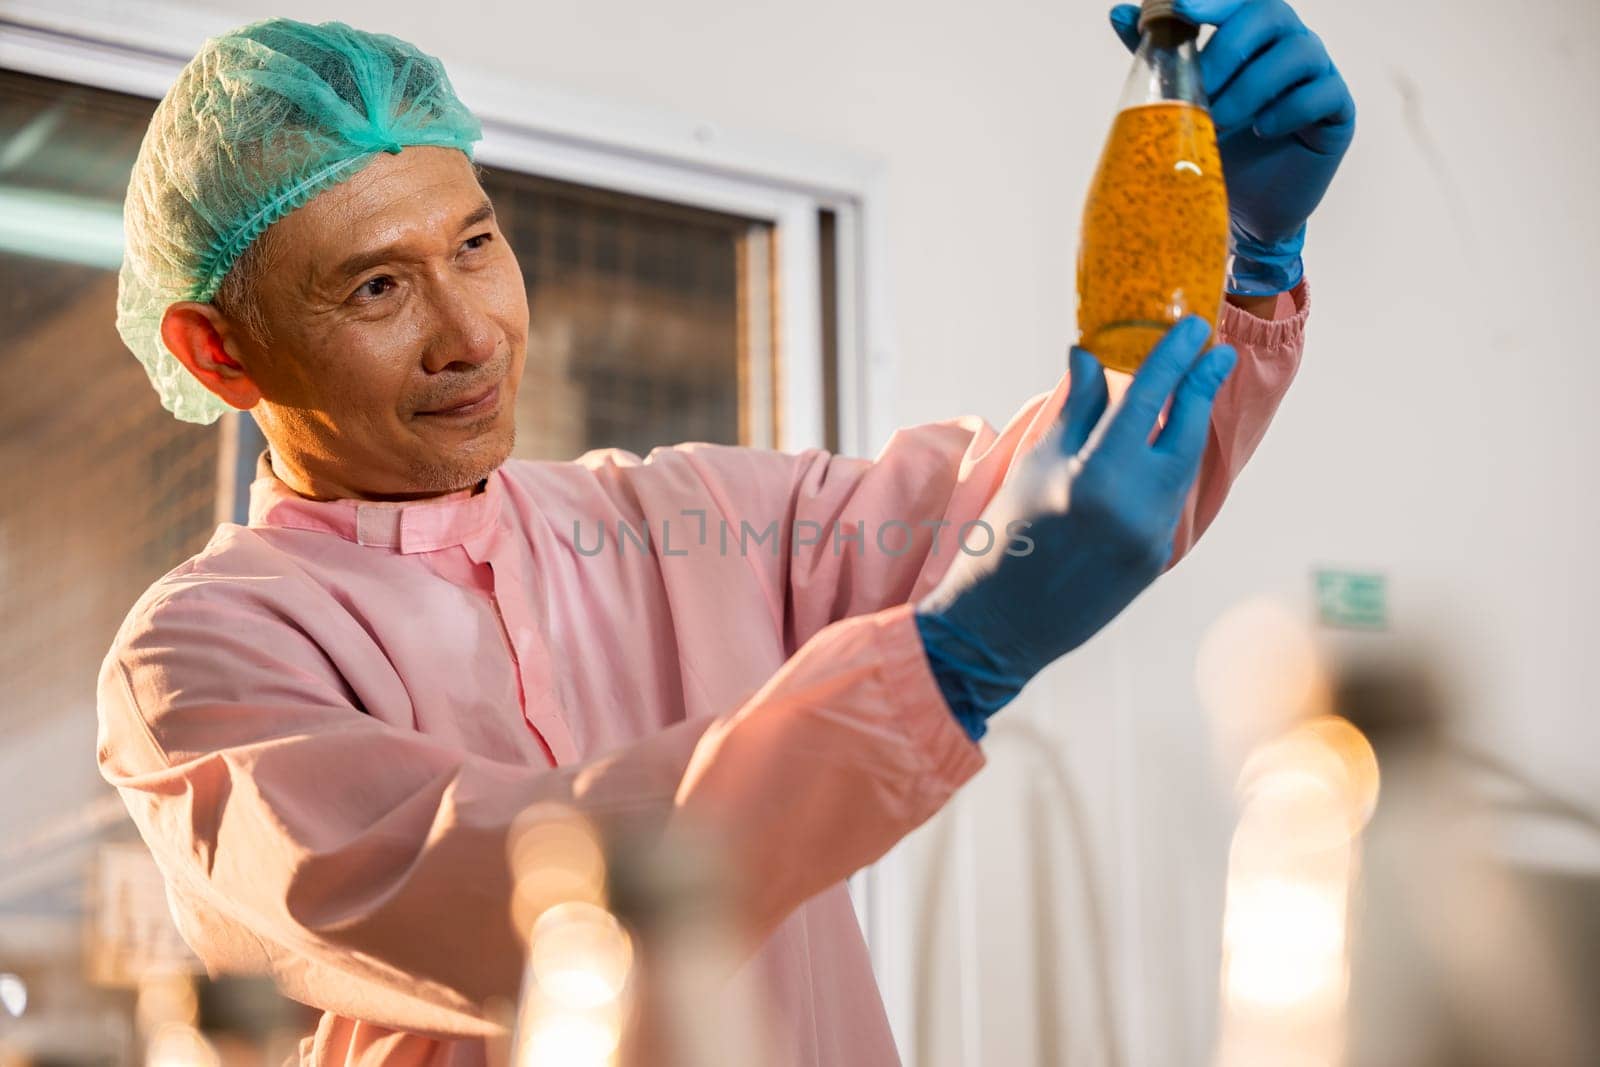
0,0,915,1062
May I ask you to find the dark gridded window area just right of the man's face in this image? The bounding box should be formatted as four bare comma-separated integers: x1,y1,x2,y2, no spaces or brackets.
483,171,770,459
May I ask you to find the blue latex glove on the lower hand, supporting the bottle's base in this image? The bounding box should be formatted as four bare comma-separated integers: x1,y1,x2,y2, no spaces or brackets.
917,317,1237,741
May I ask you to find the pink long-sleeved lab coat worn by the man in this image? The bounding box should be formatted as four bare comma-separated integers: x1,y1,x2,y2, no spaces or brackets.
99,288,1307,1067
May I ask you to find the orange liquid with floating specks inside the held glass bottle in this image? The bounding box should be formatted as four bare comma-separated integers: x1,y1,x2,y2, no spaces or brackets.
1078,102,1227,373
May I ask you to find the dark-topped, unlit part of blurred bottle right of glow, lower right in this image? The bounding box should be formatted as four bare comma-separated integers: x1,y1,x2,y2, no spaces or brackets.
1336,654,1600,1067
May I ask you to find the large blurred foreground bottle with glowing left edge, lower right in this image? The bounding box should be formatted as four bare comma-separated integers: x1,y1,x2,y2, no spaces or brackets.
1197,600,1600,1067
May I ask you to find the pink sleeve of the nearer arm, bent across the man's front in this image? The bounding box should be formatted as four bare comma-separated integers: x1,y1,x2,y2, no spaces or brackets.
99,581,982,1037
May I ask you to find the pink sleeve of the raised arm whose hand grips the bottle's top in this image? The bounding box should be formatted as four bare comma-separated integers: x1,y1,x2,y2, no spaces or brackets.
668,285,1310,648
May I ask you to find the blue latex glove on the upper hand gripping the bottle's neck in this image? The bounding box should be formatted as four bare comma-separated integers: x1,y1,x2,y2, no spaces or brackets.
1110,0,1355,296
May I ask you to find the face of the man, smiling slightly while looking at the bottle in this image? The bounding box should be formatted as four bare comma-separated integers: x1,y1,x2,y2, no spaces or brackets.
240,147,528,499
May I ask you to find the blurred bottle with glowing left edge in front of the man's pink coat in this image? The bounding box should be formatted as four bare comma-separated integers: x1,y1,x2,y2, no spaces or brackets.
510,805,768,1067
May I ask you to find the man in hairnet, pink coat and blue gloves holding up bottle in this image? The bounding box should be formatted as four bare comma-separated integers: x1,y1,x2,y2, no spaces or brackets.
99,0,1354,1065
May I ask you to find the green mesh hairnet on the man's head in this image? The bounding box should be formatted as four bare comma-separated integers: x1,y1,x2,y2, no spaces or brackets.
117,19,483,422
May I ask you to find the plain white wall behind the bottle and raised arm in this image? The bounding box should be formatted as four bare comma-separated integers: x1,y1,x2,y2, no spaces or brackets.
50,0,1600,1065
